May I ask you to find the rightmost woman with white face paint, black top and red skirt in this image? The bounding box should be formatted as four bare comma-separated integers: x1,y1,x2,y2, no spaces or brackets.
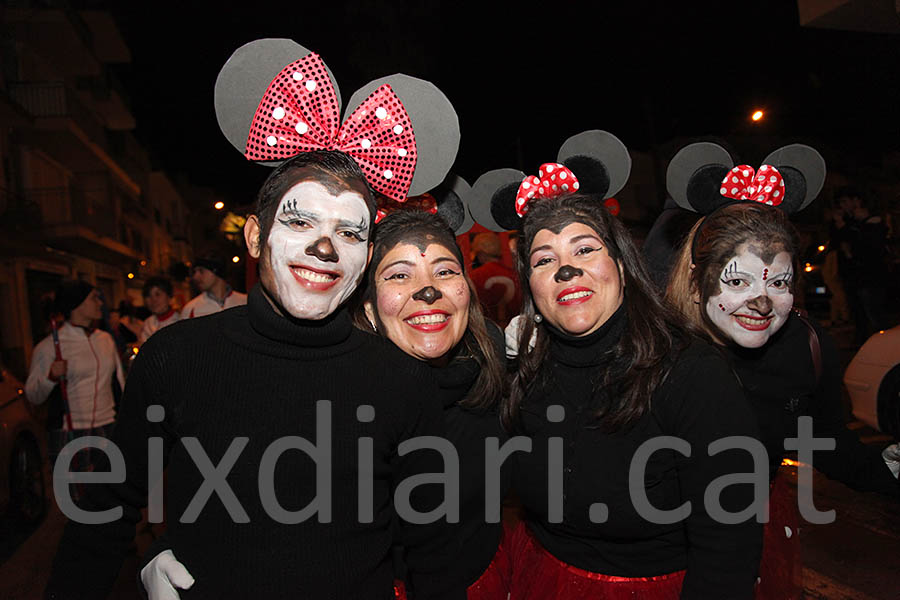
666,202,900,598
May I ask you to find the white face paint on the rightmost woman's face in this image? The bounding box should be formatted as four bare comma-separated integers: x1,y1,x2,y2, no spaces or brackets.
706,245,794,348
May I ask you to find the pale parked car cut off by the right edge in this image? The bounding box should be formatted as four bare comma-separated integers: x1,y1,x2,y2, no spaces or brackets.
844,326,900,438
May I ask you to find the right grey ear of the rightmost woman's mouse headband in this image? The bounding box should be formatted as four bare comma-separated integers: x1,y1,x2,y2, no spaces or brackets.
763,144,826,214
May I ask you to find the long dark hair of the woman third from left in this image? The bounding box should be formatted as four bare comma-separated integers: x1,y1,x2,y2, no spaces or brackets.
501,194,688,431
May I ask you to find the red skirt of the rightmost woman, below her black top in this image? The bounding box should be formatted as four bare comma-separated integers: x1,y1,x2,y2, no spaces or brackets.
756,473,803,600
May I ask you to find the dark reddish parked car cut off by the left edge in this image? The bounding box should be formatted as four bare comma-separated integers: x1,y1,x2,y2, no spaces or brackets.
0,365,47,524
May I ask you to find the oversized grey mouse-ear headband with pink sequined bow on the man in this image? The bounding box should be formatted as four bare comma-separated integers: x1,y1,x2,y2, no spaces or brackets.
215,39,459,202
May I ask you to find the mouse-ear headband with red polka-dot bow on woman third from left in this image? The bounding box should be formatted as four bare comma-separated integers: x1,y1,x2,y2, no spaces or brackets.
469,129,631,231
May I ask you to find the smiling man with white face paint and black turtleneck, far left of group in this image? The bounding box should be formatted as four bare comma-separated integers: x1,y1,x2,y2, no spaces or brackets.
47,151,453,598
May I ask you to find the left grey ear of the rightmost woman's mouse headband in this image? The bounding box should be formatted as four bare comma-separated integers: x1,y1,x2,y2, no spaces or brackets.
666,142,734,214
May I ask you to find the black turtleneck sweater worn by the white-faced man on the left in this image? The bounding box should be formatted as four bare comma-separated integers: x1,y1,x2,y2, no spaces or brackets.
46,287,458,600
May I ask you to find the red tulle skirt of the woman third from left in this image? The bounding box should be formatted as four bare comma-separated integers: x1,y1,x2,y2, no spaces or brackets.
506,523,685,600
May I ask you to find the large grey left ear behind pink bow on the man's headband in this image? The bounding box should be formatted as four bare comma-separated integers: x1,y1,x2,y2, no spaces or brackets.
214,38,341,167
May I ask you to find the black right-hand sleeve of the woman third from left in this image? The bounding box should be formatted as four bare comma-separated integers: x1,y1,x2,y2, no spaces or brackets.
660,350,768,600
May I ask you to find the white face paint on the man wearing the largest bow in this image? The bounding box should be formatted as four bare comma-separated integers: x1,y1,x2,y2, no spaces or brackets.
260,181,369,319
